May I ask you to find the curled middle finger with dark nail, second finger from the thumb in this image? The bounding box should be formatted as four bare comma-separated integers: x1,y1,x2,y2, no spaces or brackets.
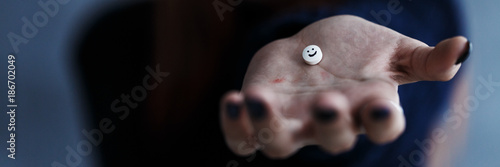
312,92,358,154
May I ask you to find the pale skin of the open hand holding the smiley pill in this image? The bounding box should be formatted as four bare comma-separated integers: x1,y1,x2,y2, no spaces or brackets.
220,15,467,158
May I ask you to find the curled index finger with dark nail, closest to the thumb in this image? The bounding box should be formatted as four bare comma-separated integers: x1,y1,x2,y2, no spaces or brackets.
360,82,405,144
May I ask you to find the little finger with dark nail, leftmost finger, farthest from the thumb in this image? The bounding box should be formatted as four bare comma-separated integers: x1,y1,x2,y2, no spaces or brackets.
220,91,257,156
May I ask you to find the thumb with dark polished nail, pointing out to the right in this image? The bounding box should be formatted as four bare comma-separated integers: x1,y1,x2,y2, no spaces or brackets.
392,36,471,83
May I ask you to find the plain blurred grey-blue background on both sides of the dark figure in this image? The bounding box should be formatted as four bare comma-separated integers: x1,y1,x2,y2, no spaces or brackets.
0,0,500,167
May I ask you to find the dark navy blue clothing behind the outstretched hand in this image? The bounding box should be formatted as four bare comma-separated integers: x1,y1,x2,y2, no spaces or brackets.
230,0,463,167
